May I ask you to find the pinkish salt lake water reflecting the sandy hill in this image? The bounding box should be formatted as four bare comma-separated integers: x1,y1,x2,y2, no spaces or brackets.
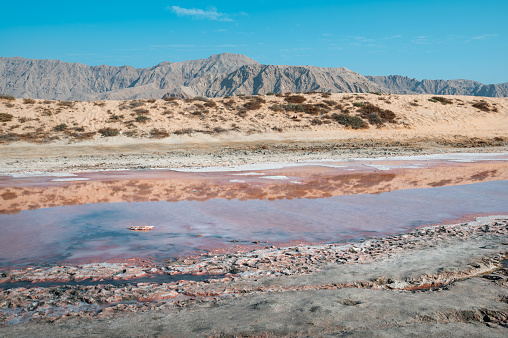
0,157,508,267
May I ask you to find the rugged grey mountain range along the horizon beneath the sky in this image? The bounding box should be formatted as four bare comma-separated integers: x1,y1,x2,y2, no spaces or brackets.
0,53,508,101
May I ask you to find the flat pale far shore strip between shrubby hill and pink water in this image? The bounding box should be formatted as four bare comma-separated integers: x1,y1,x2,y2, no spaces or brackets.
0,142,508,176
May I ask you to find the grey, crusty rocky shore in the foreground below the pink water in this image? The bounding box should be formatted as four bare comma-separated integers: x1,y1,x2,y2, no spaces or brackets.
0,215,508,336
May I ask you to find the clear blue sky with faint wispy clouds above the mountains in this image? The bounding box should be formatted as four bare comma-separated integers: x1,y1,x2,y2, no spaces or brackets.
0,0,508,83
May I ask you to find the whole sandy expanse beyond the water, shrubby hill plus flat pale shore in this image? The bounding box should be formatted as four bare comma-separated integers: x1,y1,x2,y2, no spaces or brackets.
0,93,508,173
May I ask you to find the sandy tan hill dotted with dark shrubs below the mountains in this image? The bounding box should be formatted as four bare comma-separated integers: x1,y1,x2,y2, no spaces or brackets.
0,93,508,148
